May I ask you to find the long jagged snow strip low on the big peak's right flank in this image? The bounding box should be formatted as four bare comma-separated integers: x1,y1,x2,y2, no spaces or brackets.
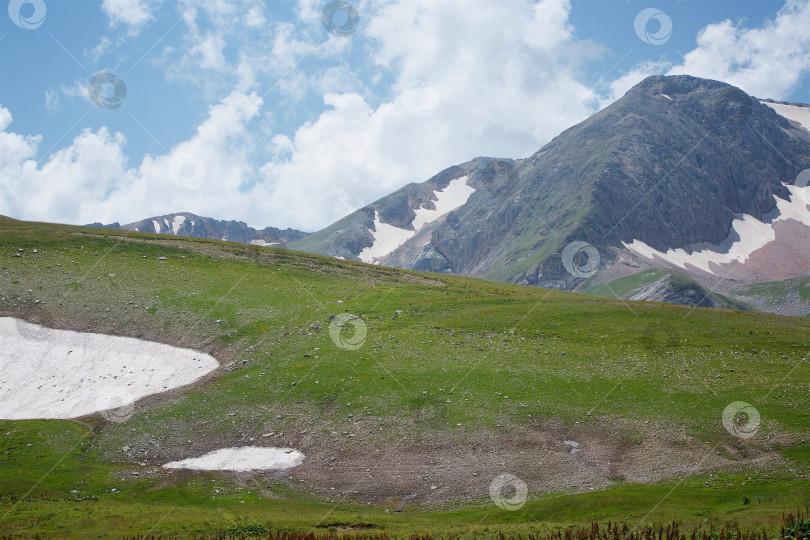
622,184,810,274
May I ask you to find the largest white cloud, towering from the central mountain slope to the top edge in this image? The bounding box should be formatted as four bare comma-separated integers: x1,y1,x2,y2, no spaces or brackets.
251,0,598,229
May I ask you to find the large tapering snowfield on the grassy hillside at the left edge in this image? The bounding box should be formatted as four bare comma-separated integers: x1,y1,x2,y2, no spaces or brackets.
0,317,219,420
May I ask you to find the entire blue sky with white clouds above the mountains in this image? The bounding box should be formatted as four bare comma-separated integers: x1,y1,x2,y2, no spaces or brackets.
0,0,810,230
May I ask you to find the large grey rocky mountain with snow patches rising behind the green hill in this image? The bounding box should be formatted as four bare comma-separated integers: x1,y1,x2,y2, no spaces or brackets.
291,76,810,306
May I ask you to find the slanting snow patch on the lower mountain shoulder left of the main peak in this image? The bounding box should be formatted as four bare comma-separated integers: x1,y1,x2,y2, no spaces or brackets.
358,176,475,264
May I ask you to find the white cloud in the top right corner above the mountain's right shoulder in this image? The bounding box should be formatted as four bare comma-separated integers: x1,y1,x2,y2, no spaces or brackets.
669,0,810,99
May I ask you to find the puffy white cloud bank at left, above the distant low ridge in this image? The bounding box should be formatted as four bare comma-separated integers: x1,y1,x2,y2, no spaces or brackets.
0,92,262,227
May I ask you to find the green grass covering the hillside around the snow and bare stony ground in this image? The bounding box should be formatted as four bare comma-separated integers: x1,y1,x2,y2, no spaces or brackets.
0,221,810,537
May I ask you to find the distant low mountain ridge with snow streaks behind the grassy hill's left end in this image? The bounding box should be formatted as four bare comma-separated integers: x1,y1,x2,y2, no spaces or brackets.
90,212,310,247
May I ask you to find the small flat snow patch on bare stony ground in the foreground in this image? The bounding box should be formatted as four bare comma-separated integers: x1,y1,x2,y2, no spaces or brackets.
163,446,304,471
